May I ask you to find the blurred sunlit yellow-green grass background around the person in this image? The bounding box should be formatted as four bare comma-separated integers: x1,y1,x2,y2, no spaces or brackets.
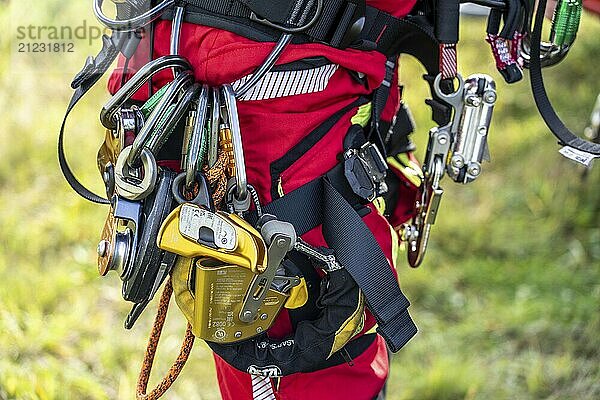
0,0,600,400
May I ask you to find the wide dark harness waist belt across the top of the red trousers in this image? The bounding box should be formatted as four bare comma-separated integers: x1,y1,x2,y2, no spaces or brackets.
163,0,433,56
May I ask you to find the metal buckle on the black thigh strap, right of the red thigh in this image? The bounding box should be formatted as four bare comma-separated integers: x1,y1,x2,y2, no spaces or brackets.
344,142,388,202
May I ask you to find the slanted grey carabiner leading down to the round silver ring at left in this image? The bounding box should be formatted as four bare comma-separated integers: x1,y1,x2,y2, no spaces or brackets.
127,72,193,166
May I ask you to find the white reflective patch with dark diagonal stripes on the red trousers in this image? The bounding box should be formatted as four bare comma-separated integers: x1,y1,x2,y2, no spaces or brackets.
231,64,339,101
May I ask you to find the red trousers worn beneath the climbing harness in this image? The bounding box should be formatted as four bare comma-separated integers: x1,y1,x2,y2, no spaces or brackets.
109,1,414,400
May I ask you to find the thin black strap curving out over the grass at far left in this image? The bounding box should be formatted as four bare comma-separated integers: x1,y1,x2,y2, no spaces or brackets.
58,34,124,204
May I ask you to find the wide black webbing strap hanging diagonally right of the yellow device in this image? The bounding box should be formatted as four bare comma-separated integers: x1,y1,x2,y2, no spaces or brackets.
248,167,417,352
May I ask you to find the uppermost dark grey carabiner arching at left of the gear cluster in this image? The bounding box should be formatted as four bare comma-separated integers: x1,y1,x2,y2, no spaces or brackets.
100,56,192,129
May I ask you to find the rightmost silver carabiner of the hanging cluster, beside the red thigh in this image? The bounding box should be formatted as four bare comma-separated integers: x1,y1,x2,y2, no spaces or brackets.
223,85,248,200
